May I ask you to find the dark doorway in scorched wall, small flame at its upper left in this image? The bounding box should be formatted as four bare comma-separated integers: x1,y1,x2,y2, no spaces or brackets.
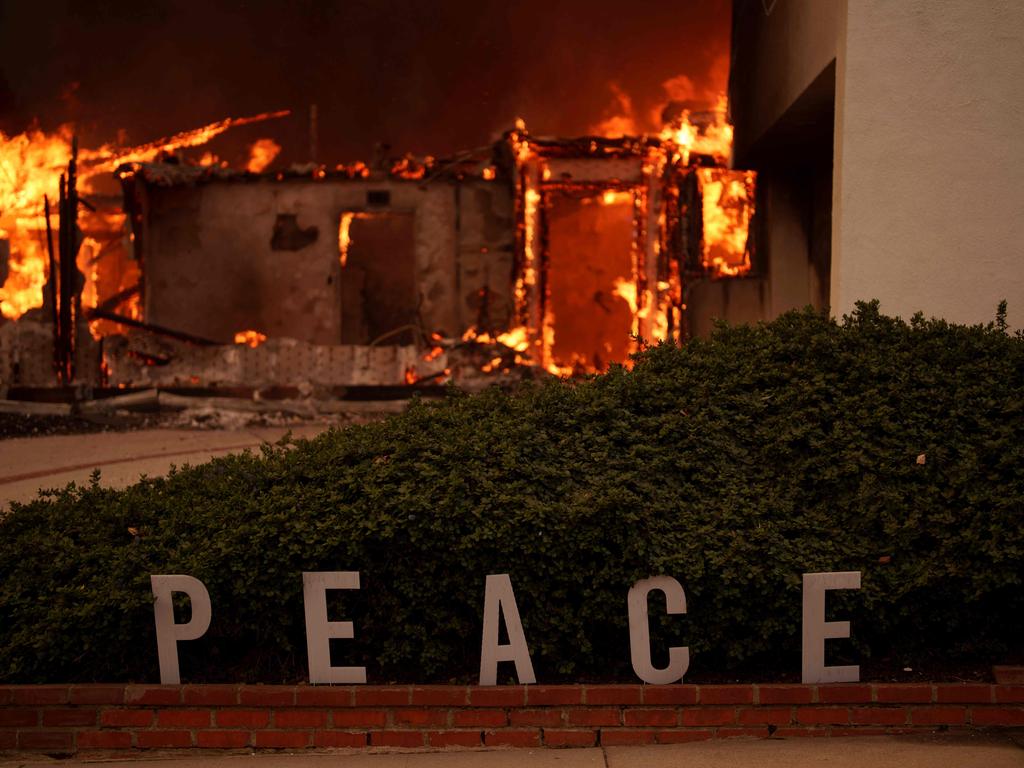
338,210,420,346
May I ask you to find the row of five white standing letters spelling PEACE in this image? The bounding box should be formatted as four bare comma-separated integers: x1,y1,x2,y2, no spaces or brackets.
150,570,860,685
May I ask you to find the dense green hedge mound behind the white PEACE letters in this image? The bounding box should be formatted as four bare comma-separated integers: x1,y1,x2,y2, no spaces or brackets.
0,304,1024,682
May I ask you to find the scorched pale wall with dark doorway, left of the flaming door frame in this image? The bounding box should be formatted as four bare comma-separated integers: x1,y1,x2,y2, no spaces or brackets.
139,177,513,345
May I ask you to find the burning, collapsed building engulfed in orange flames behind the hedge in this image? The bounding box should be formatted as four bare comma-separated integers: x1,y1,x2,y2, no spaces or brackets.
0,105,755,396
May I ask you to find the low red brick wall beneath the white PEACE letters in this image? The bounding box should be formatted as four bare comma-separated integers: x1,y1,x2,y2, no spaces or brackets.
0,683,1024,754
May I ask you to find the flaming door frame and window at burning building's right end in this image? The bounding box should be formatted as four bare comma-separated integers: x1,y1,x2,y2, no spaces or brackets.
509,115,755,375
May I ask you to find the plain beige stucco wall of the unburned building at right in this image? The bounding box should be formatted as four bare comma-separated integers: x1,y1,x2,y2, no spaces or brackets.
831,0,1024,328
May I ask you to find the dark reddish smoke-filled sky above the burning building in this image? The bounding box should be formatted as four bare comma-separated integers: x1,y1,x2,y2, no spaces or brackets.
0,0,730,162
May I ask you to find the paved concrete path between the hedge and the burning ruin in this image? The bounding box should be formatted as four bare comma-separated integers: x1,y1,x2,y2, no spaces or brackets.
0,424,328,510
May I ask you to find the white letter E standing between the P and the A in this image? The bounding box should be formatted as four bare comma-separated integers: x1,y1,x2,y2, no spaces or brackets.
302,570,367,685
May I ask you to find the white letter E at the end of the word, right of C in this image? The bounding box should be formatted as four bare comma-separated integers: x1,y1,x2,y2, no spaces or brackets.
802,570,860,683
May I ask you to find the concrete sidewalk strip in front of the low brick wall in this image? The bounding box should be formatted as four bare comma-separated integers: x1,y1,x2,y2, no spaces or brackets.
0,734,1024,768
